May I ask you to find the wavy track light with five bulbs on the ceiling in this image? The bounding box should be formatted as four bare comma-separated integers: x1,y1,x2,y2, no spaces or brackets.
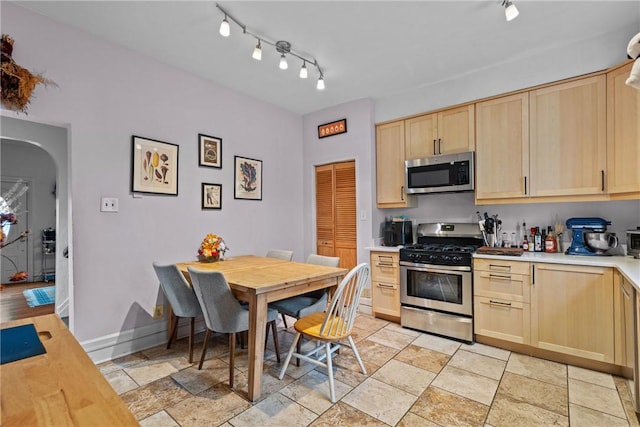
216,0,324,90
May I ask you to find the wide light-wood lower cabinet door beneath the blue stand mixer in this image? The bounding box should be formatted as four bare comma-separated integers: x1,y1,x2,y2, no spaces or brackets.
531,263,614,363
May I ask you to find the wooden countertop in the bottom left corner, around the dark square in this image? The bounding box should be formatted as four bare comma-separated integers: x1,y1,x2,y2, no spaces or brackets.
0,314,139,427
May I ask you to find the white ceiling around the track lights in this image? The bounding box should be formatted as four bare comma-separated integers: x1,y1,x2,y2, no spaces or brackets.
10,0,640,114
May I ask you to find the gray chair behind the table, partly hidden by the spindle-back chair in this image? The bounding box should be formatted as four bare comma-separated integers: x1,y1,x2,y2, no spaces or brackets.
269,254,340,366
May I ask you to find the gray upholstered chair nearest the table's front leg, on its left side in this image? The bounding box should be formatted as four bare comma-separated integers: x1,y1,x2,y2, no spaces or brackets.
188,267,280,388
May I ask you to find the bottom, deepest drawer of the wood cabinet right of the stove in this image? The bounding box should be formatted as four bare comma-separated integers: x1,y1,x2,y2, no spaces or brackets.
474,296,531,345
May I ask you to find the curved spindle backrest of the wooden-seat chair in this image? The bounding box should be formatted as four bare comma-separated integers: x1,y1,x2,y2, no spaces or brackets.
320,263,370,337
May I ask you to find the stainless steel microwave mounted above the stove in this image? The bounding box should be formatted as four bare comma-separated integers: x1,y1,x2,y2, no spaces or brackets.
404,151,475,194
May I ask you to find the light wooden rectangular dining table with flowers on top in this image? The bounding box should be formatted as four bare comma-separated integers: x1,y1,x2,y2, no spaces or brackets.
177,255,348,401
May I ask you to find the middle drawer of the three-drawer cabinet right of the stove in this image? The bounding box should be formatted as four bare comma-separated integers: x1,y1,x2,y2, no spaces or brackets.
473,270,531,303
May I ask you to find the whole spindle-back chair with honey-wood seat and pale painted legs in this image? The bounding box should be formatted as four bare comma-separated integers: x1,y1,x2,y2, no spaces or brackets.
278,263,370,403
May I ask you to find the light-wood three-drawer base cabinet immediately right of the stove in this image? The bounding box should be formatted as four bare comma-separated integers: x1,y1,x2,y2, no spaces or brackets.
473,259,531,345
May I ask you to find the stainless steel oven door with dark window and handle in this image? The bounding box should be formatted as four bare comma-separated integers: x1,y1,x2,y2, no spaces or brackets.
400,261,473,316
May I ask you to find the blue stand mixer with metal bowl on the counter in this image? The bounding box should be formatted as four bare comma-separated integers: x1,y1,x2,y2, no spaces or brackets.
565,218,618,255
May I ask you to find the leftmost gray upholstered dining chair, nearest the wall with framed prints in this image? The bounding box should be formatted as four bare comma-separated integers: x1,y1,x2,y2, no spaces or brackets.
153,262,202,363
